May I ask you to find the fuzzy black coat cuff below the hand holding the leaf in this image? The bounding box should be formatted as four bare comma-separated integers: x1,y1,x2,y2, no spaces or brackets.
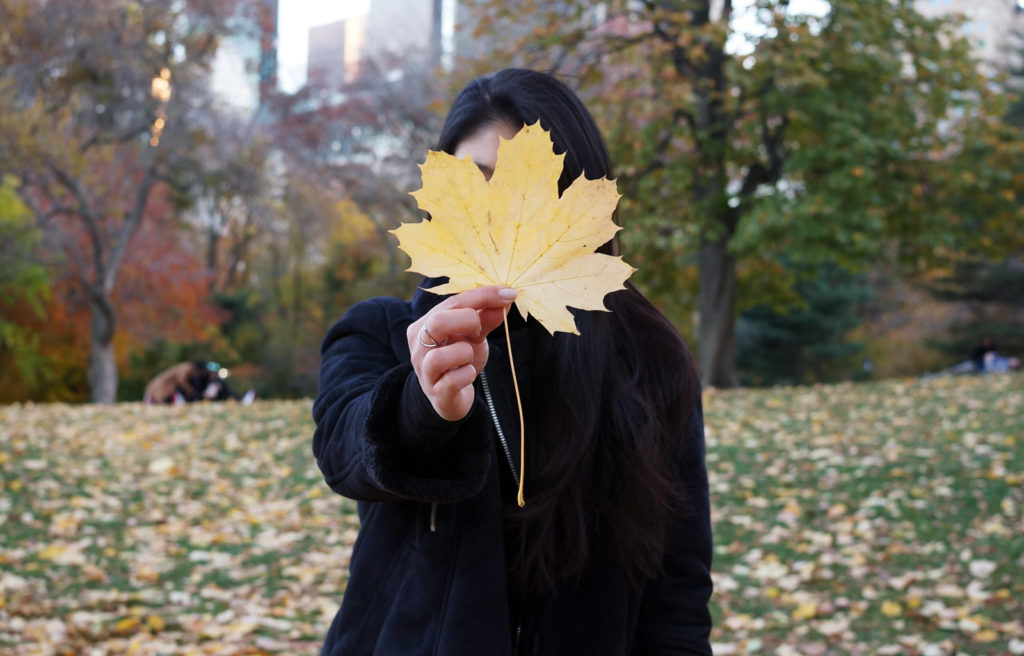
364,363,492,502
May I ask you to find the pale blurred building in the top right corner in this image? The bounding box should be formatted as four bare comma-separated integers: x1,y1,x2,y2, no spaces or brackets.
916,0,1024,67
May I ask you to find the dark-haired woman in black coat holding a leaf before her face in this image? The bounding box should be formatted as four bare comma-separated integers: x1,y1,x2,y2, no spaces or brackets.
313,70,712,656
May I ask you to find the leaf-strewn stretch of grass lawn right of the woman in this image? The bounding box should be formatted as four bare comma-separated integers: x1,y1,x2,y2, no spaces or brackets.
706,375,1024,656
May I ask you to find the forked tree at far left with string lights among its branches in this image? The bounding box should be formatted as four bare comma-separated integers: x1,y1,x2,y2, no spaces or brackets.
0,0,231,403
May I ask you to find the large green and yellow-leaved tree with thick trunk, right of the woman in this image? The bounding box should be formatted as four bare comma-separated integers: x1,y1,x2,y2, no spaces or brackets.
468,0,1020,387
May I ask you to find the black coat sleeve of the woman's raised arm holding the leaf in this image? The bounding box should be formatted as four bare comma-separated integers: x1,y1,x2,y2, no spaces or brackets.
313,299,490,502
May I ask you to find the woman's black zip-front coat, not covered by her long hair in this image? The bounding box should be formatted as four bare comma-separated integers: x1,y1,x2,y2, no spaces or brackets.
313,292,712,656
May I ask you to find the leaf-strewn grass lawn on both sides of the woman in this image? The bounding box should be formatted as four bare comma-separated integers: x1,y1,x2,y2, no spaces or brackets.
0,375,1024,656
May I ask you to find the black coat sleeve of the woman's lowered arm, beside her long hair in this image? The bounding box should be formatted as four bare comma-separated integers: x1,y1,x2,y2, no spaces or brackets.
637,405,712,656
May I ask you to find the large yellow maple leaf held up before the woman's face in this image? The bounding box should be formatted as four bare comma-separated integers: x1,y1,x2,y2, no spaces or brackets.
393,123,635,335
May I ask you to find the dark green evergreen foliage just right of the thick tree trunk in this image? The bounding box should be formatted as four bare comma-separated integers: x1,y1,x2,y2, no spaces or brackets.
736,265,870,385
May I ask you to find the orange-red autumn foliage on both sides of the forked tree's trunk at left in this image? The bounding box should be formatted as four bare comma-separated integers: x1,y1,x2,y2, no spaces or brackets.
0,185,227,402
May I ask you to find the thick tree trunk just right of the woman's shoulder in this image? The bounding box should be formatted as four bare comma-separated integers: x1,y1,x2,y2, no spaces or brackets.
697,235,739,387
